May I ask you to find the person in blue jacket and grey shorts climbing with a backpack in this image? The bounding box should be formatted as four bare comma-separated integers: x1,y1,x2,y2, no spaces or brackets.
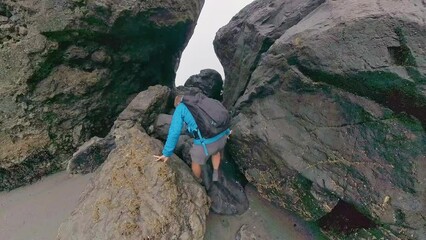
154,94,231,181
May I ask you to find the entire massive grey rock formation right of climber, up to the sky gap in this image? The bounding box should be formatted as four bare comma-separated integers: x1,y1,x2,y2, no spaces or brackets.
215,0,426,239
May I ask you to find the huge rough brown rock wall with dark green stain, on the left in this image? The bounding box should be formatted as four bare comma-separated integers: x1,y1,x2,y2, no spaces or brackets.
0,0,204,191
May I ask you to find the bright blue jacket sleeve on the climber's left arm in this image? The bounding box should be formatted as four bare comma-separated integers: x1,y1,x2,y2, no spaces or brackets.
163,103,198,157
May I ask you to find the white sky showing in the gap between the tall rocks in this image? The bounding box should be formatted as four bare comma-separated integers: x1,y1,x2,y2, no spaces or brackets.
175,0,253,86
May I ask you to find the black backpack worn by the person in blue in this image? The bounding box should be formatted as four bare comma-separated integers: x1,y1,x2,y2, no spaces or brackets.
182,93,231,138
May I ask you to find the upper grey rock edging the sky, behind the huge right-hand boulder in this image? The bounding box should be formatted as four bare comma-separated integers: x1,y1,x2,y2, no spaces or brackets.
213,0,325,108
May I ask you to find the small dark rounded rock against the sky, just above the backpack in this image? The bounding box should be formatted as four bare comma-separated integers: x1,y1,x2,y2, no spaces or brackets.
184,69,223,99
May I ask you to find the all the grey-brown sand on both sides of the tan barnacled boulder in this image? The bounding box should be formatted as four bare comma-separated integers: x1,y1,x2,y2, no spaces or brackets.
0,172,314,240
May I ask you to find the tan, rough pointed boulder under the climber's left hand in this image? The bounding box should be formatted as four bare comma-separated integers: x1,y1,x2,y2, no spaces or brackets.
57,125,209,240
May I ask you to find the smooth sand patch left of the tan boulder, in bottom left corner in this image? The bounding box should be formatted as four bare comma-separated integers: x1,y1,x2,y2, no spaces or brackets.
0,172,92,240
